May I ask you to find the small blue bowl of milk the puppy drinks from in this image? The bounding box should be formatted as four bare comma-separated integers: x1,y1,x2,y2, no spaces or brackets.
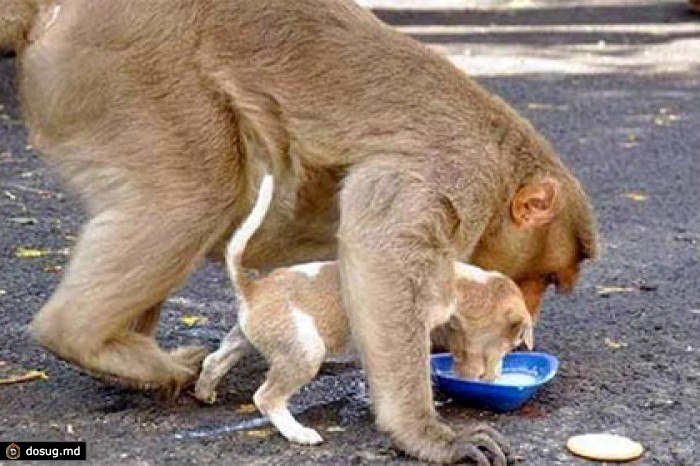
430,353,559,412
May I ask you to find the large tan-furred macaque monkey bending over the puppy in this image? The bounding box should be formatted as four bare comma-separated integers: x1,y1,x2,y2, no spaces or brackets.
0,0,596,465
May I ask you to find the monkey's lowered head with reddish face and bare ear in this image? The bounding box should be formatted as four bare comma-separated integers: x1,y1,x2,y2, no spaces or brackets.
471,174,597,321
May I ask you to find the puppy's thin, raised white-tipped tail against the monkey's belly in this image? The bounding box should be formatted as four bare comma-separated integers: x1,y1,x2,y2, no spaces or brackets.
226,175,275,288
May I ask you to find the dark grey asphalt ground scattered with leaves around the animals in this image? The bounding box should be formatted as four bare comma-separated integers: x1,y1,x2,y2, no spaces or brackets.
0,0,700,465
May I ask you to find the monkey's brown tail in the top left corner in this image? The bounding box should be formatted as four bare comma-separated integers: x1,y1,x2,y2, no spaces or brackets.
0,0,41,52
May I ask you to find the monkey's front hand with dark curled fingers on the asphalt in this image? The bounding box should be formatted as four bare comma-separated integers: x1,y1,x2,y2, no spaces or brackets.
394,419,515,466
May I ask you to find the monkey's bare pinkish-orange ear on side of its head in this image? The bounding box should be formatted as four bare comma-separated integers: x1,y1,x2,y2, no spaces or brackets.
510,178,559,228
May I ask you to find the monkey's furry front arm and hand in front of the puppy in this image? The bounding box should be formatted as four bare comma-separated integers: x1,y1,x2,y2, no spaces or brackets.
338,165,510,466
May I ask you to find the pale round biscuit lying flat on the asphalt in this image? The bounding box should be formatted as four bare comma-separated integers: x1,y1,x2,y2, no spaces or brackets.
566,434,644,461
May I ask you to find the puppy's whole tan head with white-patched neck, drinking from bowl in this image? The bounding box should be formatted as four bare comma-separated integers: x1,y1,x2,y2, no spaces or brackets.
446,266,535,381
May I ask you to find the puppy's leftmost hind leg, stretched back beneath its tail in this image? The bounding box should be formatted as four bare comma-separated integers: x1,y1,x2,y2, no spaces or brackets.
194,325,254,404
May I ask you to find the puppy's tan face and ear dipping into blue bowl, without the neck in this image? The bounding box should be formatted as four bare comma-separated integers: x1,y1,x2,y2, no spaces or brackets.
447,292,534,382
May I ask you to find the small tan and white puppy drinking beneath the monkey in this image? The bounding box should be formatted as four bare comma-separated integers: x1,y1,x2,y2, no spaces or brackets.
195,175,533,445
